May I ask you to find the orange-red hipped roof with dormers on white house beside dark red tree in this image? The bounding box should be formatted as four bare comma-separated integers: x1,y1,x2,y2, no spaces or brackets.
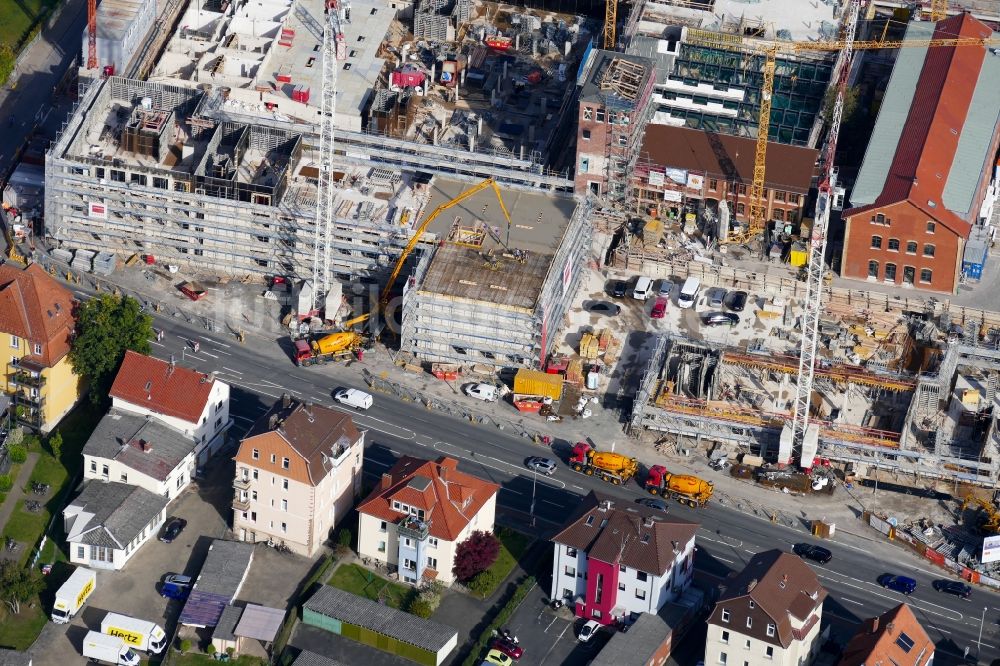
358,456,500,541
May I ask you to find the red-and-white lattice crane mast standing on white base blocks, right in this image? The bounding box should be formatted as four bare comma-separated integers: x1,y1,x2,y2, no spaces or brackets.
778,2,858,468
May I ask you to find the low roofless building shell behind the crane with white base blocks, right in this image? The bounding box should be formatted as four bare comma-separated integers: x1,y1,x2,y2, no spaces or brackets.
631,336,1000,486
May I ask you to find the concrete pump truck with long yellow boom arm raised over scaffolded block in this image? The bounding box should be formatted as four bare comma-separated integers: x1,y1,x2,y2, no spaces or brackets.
294,178,511,365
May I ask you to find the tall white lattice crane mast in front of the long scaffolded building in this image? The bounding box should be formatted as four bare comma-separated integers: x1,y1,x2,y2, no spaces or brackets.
312,0,351,310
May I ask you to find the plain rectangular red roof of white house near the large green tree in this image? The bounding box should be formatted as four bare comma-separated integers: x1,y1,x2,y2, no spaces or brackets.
111,351,215,423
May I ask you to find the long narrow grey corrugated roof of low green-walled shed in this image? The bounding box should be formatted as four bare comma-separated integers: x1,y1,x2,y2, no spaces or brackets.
304,585,458,652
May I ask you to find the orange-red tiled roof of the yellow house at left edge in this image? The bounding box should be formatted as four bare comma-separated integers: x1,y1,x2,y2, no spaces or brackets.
0,264,75,368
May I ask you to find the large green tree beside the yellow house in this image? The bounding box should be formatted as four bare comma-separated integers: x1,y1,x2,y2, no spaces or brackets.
69,294,153,404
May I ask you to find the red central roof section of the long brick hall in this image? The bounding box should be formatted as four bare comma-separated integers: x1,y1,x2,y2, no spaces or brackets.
844,13,992,238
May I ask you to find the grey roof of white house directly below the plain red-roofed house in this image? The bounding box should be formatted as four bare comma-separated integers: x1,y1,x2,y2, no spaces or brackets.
83,409,195,481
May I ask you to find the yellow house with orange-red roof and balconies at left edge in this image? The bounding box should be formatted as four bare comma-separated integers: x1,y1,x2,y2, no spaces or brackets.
0,264,81,432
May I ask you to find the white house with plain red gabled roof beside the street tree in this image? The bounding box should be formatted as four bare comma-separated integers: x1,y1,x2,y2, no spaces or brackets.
110,351,233,465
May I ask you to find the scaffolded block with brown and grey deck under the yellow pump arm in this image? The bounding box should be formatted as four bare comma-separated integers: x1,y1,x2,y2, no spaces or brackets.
400,181,591,368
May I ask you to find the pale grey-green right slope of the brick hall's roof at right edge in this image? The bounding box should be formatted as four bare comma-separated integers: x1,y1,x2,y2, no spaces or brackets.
940,49,1000,219
